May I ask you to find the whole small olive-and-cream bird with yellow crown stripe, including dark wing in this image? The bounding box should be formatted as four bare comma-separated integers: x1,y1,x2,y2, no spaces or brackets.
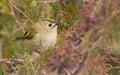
15,19,59,51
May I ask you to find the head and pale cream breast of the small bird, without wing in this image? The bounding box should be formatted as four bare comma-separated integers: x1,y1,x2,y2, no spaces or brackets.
33,19,59,49
